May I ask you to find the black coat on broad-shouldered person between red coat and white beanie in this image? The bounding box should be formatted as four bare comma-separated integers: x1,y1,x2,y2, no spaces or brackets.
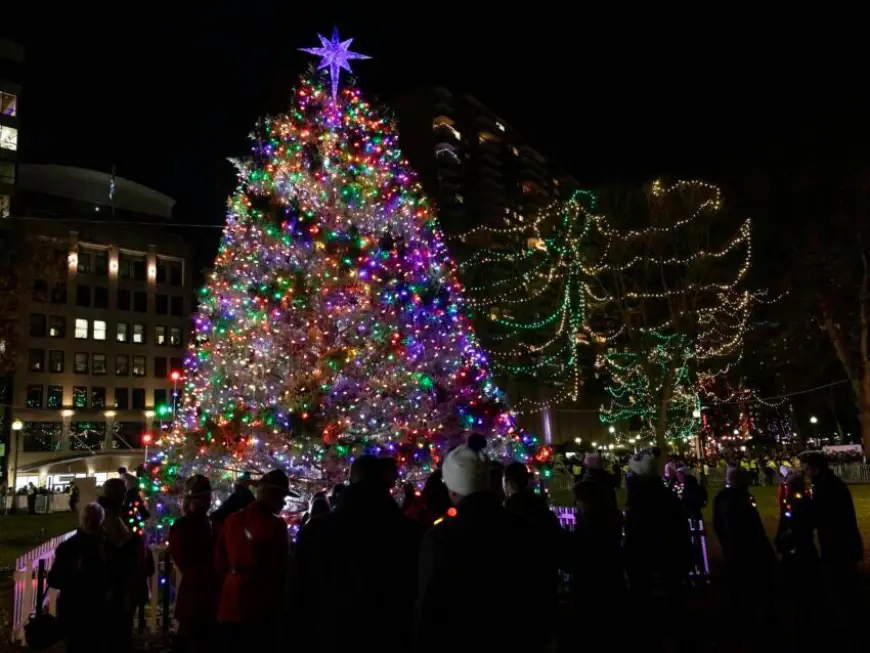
283,483,421,653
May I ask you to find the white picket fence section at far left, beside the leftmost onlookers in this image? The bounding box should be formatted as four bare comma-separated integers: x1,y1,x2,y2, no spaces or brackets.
12,531,75,644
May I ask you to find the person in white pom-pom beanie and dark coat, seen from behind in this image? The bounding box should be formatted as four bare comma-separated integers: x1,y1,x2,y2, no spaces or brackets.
412,443,552,653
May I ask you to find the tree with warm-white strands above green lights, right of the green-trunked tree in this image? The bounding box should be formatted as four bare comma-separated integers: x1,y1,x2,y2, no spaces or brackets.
584,181,760,447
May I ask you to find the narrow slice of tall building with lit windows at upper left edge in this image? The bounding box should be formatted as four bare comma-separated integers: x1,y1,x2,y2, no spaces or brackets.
0,39,24,218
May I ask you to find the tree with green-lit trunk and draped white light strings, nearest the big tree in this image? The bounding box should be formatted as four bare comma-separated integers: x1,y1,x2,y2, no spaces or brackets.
454,191,611,413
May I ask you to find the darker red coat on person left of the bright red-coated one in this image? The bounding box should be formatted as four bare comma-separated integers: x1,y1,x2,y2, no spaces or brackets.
169,516,220,621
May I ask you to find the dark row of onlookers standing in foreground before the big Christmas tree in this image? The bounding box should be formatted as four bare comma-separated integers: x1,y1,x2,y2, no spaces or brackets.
42,436,863,653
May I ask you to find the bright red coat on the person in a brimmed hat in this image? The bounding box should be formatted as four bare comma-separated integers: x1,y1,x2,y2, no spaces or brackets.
215,501,289,624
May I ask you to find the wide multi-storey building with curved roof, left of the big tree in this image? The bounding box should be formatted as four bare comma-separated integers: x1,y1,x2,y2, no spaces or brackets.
0,164,193,489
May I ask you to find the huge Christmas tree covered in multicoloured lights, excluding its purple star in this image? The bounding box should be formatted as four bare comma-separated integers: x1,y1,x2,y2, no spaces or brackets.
151,65,546,528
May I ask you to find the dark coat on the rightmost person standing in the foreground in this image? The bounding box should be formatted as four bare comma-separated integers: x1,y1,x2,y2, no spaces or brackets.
812,470,864,565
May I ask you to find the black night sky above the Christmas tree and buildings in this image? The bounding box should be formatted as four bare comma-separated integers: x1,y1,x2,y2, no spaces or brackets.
0,5,870,229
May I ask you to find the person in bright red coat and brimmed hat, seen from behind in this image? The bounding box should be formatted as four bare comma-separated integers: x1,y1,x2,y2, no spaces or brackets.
215,469,290,651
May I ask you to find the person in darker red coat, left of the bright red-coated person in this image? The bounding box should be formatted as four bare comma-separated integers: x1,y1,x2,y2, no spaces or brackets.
169,474,220,653
